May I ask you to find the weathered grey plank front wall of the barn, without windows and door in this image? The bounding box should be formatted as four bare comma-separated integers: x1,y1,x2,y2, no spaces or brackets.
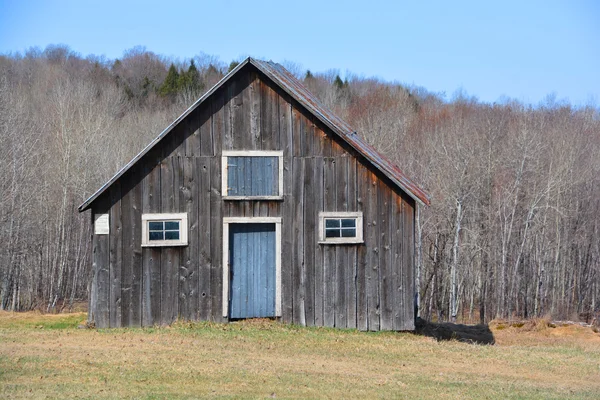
90,66,415,330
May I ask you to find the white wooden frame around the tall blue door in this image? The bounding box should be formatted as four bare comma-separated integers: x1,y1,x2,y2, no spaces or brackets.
223,217,281,318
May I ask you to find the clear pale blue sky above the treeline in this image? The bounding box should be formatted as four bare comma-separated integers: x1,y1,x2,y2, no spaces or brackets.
0,0,600,106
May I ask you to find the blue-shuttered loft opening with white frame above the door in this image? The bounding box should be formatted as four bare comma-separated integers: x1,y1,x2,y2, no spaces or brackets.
221,150,283,200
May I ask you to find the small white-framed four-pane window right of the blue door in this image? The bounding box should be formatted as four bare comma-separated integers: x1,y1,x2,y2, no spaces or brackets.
319,211,364,244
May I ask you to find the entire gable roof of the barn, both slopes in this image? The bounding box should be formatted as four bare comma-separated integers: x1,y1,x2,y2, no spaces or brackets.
79,57,430,212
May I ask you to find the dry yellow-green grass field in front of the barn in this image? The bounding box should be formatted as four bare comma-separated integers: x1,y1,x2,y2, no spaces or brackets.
0,312,600,399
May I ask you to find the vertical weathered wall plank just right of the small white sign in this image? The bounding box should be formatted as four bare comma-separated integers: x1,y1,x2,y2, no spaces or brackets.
109,181,123,328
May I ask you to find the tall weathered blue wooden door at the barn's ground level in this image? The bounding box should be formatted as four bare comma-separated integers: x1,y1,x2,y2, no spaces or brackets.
229,223,276,319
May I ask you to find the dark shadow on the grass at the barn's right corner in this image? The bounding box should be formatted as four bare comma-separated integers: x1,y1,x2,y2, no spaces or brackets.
415,318,495,344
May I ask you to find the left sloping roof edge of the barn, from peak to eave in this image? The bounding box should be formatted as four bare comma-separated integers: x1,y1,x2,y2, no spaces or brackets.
77,57,251,212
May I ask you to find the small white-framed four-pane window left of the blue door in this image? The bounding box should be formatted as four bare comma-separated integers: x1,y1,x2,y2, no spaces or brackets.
142,213,188,247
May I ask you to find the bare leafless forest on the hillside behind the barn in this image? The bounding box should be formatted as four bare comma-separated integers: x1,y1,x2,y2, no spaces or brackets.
0,46,600,322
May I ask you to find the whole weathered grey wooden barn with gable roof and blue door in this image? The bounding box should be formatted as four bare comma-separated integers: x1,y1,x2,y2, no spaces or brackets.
79,58,429,330
